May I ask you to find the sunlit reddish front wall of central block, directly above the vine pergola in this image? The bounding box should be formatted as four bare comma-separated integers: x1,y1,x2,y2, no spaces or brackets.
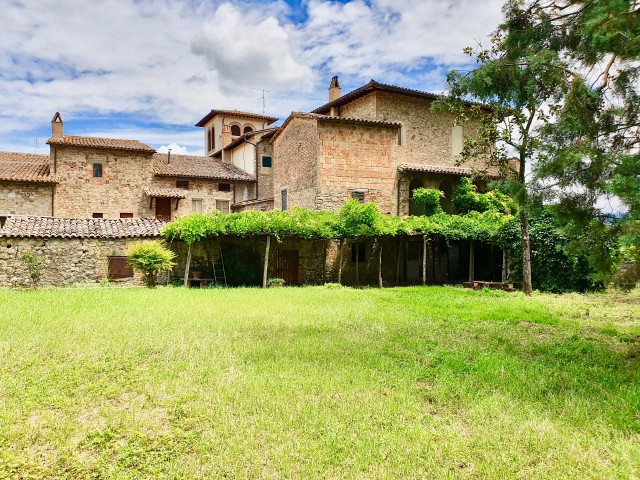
315,121,398,214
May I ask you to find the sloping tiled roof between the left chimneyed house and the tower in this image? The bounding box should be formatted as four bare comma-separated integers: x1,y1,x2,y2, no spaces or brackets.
153,153,255,182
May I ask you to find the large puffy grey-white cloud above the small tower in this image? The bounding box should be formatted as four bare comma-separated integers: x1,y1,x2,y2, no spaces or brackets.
191,3,313,92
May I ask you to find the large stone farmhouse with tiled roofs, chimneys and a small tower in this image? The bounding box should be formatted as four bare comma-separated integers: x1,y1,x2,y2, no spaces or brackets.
0,77,502,284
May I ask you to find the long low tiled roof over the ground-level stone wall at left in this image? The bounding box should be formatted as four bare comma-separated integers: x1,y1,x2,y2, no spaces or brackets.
0,216,166,238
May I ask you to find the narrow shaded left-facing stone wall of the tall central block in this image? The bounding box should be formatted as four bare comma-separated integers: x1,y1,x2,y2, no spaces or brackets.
272,117,318,210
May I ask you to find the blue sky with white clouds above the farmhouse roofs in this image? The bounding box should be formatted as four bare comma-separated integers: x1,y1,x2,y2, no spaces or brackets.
0,0,502,154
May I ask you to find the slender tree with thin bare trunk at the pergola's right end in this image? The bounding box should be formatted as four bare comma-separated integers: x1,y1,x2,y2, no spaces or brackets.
435,1,572,295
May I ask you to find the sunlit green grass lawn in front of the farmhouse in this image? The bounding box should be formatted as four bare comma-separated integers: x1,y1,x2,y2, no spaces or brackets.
0,287,640,479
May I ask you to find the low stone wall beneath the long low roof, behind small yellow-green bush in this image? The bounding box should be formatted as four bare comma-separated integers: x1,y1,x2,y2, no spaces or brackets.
0,237,141,287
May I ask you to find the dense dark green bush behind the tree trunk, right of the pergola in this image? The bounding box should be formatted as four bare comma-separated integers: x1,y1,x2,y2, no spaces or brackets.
498,207,616,293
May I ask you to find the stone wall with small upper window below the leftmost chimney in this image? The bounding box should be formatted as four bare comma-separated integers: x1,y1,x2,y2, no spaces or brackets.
51,145,155,218
